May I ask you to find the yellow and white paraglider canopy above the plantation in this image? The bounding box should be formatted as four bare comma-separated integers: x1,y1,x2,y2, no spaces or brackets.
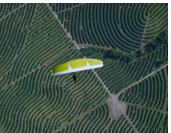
51,59,103,75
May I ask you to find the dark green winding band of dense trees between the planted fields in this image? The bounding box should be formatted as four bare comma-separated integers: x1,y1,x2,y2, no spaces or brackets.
82,29,167,67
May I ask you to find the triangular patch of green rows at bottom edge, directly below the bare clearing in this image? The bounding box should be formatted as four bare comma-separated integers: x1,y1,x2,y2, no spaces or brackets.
59,104,134,133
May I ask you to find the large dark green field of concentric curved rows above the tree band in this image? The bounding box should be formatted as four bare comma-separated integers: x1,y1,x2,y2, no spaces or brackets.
51,4,168,53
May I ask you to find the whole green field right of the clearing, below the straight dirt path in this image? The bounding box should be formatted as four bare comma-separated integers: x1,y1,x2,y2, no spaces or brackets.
119,68,168,132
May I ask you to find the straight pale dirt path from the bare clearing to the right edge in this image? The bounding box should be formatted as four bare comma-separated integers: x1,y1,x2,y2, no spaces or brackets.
117,64,168,96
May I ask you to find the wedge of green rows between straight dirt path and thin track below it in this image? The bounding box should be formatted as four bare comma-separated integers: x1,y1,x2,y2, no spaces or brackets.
119,68,168,110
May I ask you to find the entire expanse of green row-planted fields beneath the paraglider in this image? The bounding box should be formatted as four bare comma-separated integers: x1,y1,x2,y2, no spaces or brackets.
0,3,168,133
